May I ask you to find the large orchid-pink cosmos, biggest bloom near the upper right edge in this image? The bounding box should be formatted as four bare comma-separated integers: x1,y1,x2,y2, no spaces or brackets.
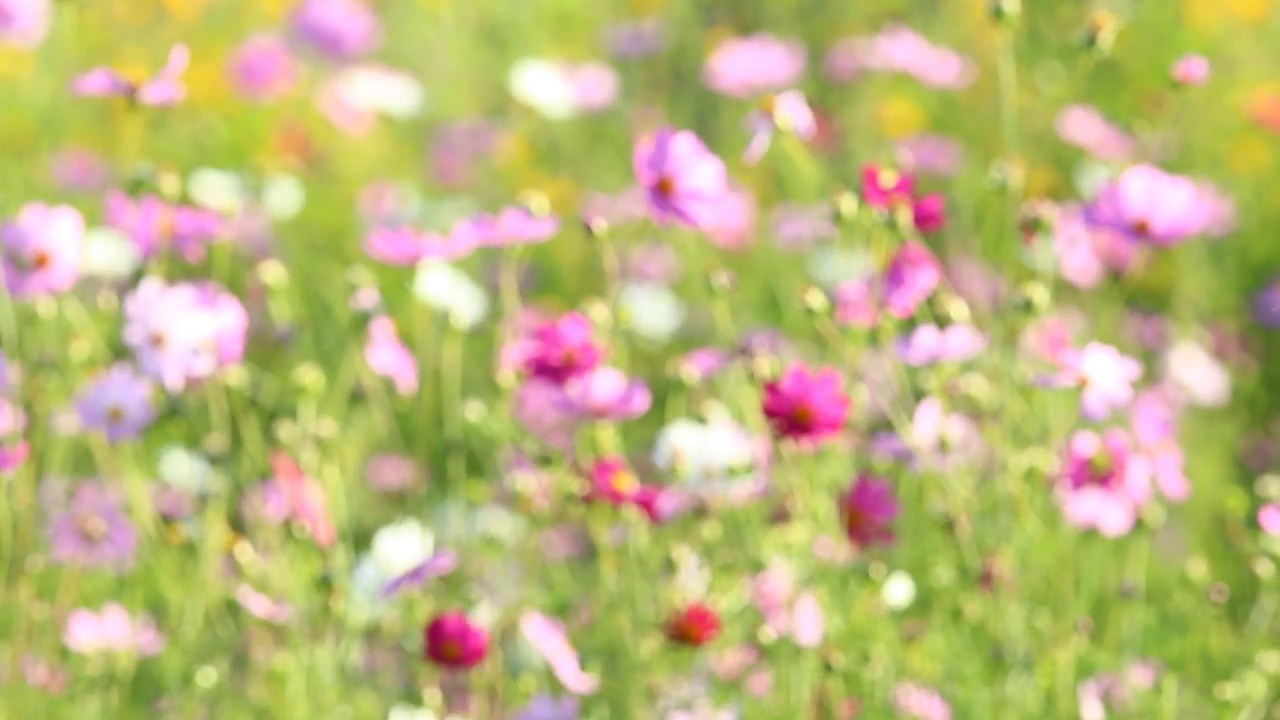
1087,165,1212,246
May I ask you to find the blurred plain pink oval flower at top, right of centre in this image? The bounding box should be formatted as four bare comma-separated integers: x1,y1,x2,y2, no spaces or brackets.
703,33,808,97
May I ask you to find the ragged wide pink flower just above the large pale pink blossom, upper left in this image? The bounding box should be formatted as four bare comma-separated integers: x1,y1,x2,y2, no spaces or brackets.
106,190,225,263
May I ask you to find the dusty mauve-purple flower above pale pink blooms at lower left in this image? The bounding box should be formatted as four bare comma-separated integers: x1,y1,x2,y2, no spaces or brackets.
46,480,138,571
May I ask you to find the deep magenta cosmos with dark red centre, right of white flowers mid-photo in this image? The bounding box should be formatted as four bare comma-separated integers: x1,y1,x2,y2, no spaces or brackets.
762,363,850,443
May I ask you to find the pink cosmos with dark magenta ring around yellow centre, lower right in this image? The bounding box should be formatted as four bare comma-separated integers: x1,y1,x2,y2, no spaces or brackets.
1057,428,1151,538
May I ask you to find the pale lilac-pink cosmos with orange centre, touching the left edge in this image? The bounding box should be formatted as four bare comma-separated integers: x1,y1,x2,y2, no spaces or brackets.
0,202,84,299
